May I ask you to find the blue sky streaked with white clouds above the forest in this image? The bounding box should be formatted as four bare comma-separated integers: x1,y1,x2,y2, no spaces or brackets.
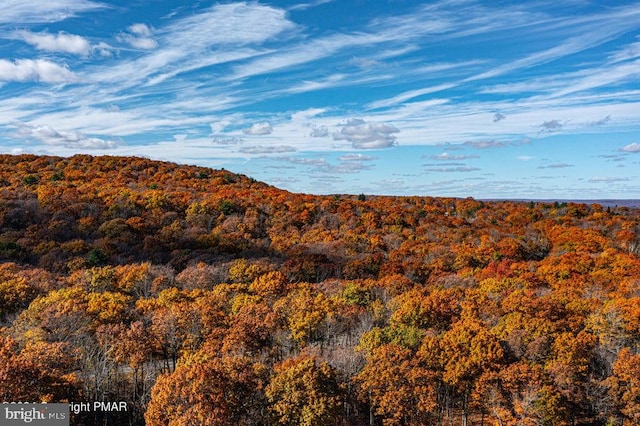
0,0,640,199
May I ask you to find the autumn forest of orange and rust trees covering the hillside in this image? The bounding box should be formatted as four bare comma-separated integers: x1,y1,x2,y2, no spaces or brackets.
0,155,640,426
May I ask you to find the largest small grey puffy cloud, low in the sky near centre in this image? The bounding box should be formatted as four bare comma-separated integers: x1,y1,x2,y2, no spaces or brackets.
333,119,400,149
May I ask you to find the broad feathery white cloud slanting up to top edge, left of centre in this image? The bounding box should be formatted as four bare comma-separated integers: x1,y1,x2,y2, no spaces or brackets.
90,3,296,91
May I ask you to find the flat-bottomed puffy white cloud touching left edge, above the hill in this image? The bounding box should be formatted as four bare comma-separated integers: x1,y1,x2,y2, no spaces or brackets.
0,59,75,83
